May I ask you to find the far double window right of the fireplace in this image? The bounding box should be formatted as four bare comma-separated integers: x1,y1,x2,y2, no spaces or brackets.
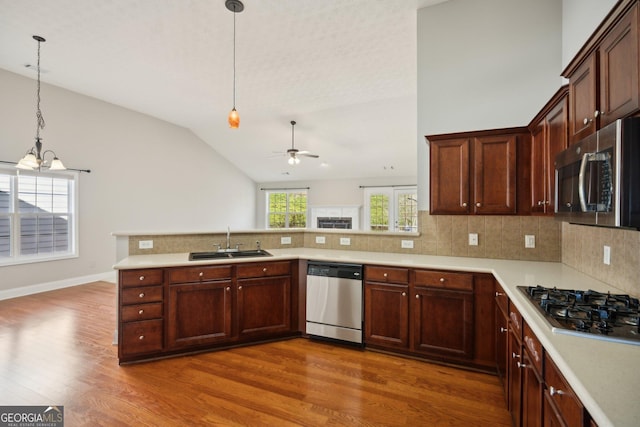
364,187,418,232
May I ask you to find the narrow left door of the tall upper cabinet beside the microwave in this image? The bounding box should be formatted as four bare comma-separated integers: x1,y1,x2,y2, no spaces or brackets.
531,120,549,213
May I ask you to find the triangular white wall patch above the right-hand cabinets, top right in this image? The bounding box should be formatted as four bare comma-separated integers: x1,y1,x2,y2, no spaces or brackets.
562,0,616,69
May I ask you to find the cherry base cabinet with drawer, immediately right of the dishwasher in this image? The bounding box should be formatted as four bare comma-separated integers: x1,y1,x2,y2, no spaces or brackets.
364,265,409,350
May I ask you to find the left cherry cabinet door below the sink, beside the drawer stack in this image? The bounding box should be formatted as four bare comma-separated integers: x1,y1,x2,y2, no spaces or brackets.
167,280,231,348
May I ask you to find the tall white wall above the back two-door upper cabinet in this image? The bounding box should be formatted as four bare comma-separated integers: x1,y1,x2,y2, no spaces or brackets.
417,0,562,210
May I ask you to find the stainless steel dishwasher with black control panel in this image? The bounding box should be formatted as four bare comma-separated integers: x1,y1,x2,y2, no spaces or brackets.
306,261,363,344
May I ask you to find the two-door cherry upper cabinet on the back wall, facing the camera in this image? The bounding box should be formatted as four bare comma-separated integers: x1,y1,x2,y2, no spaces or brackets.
427,128,530,215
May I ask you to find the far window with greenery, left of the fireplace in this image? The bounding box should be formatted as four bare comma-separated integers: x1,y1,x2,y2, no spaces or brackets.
267,190,307,228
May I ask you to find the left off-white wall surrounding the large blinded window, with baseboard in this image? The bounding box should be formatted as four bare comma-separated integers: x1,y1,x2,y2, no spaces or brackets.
0,70,256,297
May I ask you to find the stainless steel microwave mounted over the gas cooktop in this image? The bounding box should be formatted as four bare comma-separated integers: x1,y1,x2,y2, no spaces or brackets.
555,117,640,229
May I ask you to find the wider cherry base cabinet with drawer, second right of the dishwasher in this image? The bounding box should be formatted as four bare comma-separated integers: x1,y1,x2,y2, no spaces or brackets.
411,270,474,359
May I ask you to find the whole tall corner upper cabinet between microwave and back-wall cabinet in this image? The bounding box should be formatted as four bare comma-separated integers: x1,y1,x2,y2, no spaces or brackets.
529,86,569,215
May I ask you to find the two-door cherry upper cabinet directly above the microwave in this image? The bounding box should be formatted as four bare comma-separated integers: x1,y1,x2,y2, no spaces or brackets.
562,0,640,144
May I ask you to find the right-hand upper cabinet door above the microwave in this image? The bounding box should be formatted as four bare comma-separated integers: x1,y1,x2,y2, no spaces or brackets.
599,4,640,126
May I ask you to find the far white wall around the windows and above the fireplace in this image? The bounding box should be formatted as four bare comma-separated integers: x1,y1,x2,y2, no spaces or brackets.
255,176,416,229
